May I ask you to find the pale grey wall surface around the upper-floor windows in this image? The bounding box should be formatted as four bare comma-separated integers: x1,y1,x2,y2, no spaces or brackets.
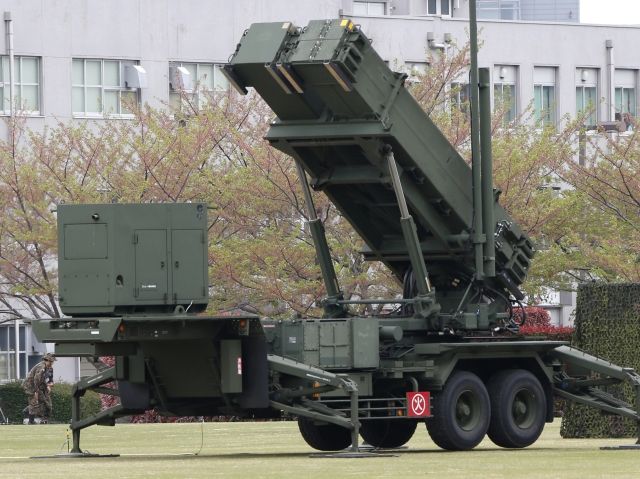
0,0,640,134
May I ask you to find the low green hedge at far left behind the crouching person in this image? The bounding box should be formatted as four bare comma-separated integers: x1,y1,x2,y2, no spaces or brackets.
0,381,101,423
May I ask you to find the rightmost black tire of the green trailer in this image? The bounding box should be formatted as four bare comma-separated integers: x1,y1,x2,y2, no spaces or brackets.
487,369,547,448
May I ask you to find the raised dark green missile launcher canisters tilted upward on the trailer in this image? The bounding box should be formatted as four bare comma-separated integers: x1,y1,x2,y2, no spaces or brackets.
225,20,533,334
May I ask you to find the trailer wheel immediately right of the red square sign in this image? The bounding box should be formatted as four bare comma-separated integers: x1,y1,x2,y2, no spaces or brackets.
427,371,491,451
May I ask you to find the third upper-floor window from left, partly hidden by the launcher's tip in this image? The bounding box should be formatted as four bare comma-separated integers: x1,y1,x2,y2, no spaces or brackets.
169,62,229,109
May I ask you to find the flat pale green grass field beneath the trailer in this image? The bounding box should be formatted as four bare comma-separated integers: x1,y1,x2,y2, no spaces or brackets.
0,422,640,479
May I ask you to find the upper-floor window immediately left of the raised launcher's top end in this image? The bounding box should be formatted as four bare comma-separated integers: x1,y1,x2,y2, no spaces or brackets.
169,63,229,112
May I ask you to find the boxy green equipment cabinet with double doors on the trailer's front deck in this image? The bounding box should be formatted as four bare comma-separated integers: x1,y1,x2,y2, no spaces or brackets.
58,203,208,316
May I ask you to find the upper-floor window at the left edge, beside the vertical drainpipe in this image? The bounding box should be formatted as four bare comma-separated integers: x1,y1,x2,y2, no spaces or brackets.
0,56,40,115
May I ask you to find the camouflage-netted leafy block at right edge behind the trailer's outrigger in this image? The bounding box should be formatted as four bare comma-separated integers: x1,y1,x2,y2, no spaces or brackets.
560,283,640,438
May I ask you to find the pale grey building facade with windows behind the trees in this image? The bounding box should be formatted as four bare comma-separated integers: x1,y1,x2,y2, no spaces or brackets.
0,0,640,381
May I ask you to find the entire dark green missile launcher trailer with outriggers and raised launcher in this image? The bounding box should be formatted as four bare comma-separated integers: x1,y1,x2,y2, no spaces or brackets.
33,11,640,454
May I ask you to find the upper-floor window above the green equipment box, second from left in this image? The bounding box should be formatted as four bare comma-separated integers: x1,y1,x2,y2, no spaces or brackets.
72,58,140,117
